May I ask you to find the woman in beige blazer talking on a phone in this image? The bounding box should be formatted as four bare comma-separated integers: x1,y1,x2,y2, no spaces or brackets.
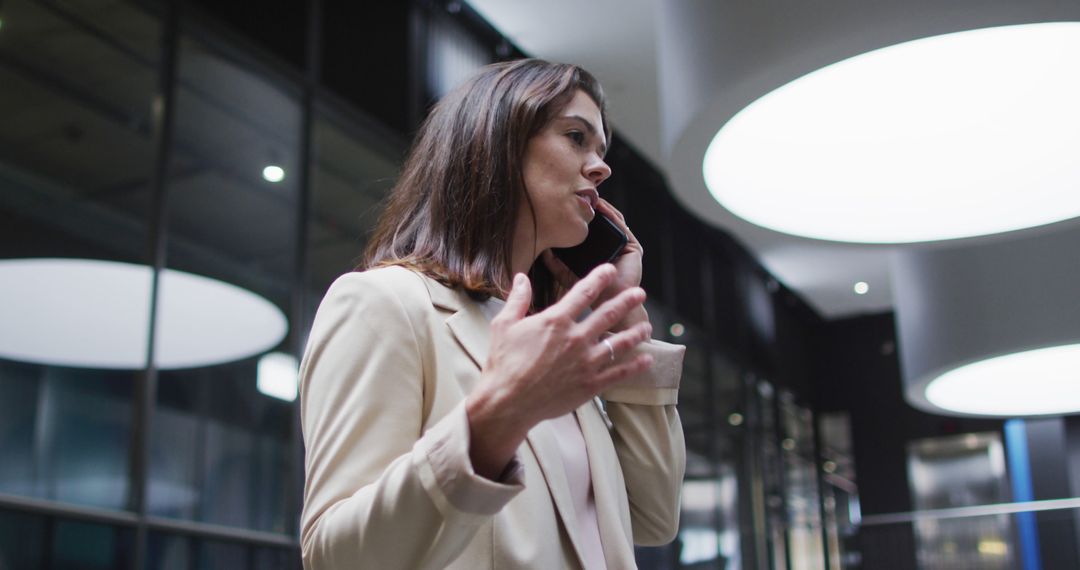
300,59,685,570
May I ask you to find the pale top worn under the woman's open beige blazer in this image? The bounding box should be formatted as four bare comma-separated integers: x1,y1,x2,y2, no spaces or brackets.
481,297,607,569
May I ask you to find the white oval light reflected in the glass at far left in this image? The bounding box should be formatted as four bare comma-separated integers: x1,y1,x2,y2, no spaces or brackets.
0,259,288,369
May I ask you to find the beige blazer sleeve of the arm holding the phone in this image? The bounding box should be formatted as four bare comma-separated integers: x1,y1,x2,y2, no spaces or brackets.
602,340,686,546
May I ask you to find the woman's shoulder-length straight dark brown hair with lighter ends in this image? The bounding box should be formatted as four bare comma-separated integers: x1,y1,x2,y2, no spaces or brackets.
357,59,611,308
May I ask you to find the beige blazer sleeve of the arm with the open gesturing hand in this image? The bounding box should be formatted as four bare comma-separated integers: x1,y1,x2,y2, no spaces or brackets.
300,270,524,569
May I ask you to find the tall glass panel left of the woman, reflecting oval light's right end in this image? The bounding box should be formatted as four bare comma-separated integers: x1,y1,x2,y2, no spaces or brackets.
149,37,301,535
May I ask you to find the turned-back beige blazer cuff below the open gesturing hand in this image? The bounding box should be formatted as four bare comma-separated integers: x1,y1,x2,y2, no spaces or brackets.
413,402,525,518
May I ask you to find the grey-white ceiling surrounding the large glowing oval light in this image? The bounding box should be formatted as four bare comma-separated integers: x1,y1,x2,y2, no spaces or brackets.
469,0,1080,320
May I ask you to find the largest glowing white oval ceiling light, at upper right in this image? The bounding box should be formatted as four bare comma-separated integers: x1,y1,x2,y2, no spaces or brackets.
703,23,1080,243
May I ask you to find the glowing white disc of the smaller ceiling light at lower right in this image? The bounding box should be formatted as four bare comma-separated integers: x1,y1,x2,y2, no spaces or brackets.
926,344,1080,416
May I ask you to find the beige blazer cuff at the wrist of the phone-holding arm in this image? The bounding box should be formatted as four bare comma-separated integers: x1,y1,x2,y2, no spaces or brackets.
600,339,686,406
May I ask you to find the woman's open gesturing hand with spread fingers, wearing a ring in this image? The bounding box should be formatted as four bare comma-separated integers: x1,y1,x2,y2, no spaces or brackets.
465,263,652,478
